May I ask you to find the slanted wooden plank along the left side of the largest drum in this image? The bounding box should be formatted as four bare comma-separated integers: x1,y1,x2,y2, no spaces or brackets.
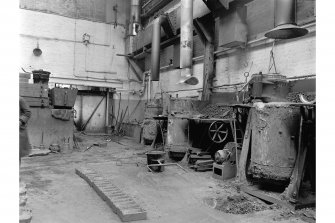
236,110,252,182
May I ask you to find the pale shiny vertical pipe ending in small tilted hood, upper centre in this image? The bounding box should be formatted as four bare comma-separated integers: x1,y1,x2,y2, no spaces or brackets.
179,0,199,85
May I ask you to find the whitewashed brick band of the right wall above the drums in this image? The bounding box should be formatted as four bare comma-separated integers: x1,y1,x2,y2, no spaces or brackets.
153,25,316,98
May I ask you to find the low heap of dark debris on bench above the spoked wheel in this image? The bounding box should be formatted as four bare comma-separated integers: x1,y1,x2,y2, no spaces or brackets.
200,104,233,118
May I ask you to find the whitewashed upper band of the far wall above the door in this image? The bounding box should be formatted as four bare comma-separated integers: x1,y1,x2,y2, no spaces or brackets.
19,9,140,89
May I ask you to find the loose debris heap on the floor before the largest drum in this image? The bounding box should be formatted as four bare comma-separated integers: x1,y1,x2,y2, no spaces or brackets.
215,195,268,214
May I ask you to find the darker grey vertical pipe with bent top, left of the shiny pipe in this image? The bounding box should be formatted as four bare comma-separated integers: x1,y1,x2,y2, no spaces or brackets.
151,16,162,81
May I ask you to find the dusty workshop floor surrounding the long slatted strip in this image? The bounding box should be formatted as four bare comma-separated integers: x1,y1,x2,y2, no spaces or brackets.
20,136,315,223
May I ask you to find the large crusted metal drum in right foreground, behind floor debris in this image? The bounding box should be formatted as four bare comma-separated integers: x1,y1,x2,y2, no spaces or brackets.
248,102,300,183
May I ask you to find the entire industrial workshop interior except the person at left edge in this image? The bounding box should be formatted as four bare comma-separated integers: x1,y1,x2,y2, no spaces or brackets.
19,0,316,223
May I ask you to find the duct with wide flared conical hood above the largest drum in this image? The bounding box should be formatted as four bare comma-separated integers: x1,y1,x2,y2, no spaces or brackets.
265,0,308,39
